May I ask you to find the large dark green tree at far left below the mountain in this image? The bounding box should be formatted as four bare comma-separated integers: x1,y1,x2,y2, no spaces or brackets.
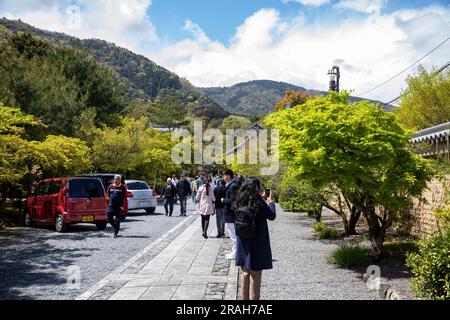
0,33,125,139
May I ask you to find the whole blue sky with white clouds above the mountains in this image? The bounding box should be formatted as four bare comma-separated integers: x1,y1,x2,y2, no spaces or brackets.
0,0,450,102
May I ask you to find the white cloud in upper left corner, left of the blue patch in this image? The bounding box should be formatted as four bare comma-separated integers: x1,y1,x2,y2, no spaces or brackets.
0,0,158,50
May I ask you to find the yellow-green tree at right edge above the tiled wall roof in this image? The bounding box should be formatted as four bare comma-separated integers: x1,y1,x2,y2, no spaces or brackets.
395,66,450,130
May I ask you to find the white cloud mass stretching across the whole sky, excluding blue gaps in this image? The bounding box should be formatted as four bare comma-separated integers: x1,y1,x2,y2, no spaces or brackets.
0,0,450,101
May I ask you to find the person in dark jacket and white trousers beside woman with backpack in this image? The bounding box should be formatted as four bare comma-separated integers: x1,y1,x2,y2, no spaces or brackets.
221,170,239,260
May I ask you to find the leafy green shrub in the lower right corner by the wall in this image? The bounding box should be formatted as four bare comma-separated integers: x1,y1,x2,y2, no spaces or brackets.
406,226,450,300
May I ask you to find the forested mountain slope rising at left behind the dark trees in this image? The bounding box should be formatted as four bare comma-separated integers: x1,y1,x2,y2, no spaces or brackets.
0,19,229,119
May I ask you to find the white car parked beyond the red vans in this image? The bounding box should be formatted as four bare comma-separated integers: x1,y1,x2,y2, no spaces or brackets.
126,180,158,214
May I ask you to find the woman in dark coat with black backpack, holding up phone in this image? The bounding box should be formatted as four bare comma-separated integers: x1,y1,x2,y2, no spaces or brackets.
234,177,276,300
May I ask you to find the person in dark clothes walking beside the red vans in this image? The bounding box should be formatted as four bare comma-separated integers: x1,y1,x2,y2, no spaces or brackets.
107,175,128,238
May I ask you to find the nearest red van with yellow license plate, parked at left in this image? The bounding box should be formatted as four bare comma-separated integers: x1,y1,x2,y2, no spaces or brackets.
25,177,108,232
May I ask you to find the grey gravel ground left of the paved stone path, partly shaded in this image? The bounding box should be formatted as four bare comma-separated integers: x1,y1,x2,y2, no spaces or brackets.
0,202,197,300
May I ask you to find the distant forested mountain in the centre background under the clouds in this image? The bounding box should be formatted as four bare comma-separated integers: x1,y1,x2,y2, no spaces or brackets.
199,80,392,116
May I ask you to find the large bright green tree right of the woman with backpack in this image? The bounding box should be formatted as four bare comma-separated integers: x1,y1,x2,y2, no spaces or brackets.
266,92,432,256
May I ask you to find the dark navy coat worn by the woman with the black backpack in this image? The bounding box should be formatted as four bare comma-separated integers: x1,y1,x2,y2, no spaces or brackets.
236,203,276,271
